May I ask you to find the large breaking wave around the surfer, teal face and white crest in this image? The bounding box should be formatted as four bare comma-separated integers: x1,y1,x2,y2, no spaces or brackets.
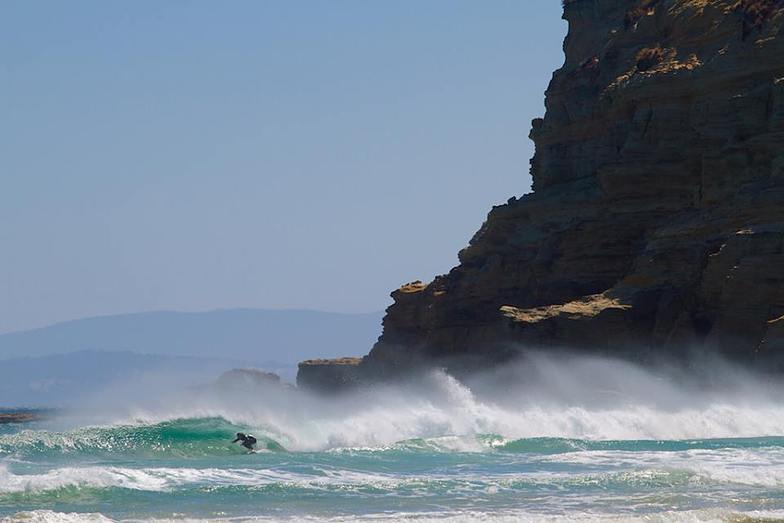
0,360,784,458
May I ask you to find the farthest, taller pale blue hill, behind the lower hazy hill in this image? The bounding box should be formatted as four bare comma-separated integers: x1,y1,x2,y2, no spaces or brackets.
0,309,382,365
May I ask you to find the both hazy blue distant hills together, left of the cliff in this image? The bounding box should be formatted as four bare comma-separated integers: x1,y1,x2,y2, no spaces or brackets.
0,309,382,407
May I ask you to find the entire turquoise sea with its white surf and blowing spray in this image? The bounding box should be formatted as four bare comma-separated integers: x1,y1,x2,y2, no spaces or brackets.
0,356,784,522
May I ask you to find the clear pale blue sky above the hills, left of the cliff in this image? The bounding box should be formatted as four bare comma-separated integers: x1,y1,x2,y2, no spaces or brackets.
0,0,566,332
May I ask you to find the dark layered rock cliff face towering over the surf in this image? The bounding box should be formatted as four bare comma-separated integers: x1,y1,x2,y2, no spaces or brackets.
303,0,784,385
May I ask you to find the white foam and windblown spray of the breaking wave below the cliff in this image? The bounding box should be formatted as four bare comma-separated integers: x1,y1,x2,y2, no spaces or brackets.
72,353,784,451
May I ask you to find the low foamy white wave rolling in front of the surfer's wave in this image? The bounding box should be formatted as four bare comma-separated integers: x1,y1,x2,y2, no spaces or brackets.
0,449,784,497
